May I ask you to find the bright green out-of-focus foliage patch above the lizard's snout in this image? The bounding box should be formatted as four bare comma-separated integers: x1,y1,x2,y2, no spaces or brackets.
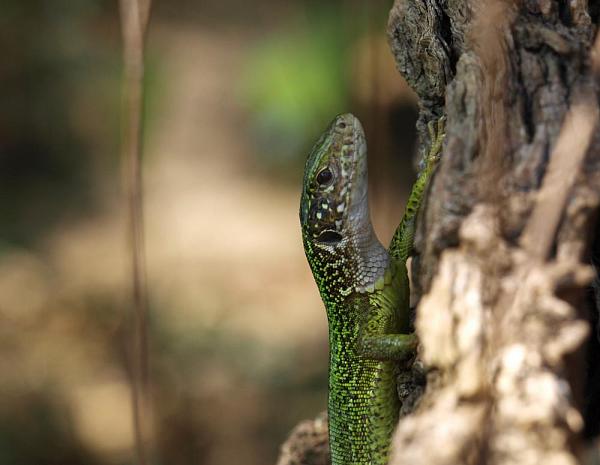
240,8,350,166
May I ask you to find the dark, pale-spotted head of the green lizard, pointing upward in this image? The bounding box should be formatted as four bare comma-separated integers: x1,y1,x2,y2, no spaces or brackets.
300,114,387,300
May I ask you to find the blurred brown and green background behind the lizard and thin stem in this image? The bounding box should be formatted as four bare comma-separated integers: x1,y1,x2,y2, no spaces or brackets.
0,0,416,465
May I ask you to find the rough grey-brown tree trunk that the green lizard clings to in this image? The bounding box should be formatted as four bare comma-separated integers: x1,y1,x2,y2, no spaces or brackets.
280,0,600,465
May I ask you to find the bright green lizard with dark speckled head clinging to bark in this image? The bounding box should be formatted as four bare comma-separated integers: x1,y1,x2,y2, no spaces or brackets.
300,114,443,465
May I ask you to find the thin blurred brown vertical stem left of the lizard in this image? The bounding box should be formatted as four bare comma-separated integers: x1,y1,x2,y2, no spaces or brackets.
120,0,151,465
